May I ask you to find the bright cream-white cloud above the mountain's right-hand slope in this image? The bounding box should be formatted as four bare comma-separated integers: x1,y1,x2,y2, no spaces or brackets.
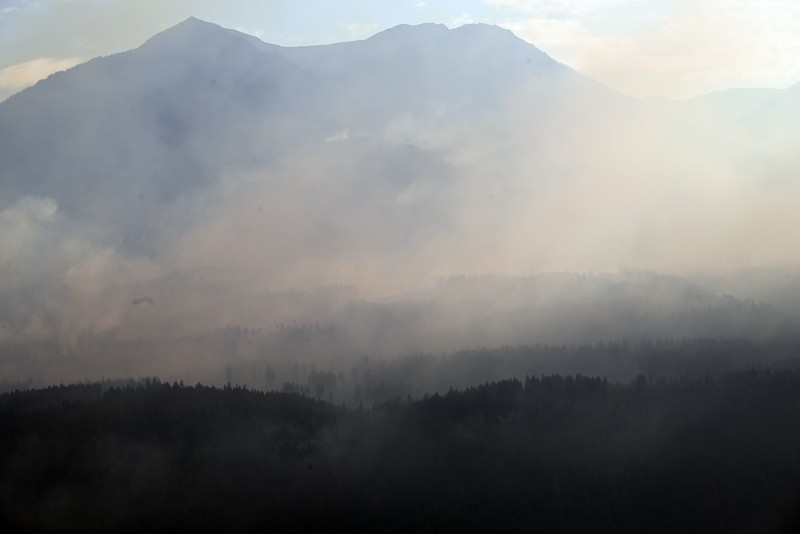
487,0,800,98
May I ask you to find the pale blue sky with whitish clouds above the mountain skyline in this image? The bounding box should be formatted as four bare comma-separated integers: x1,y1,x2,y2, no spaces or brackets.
0,0,800,100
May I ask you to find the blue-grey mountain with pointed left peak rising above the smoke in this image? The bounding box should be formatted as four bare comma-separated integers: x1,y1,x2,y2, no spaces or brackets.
0,18,608,252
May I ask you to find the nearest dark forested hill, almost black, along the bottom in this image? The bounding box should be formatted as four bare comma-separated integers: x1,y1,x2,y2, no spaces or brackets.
0,371,800,532
